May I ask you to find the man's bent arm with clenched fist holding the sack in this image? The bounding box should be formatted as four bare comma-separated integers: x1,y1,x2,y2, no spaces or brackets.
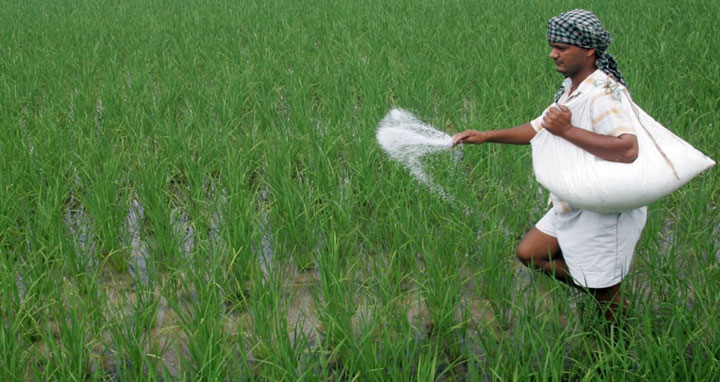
542,105,638,163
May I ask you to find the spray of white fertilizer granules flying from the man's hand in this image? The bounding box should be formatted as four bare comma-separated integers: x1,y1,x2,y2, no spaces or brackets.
377,109,454,201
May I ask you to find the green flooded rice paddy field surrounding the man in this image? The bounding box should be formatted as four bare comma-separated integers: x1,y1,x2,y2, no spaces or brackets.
0,0,720,381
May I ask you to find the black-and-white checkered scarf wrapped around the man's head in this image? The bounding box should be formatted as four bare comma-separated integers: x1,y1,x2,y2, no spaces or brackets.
547,9,625,100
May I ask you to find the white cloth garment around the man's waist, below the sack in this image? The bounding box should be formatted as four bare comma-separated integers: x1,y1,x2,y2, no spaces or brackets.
535,207,647,288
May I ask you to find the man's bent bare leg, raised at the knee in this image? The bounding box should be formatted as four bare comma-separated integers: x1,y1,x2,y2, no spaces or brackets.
517,227,572,284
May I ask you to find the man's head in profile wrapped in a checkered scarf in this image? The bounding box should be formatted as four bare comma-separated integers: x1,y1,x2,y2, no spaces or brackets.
547,9,625,84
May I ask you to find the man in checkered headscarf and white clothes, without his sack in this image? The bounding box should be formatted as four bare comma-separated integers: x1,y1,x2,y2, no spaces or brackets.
453,9,647,321
